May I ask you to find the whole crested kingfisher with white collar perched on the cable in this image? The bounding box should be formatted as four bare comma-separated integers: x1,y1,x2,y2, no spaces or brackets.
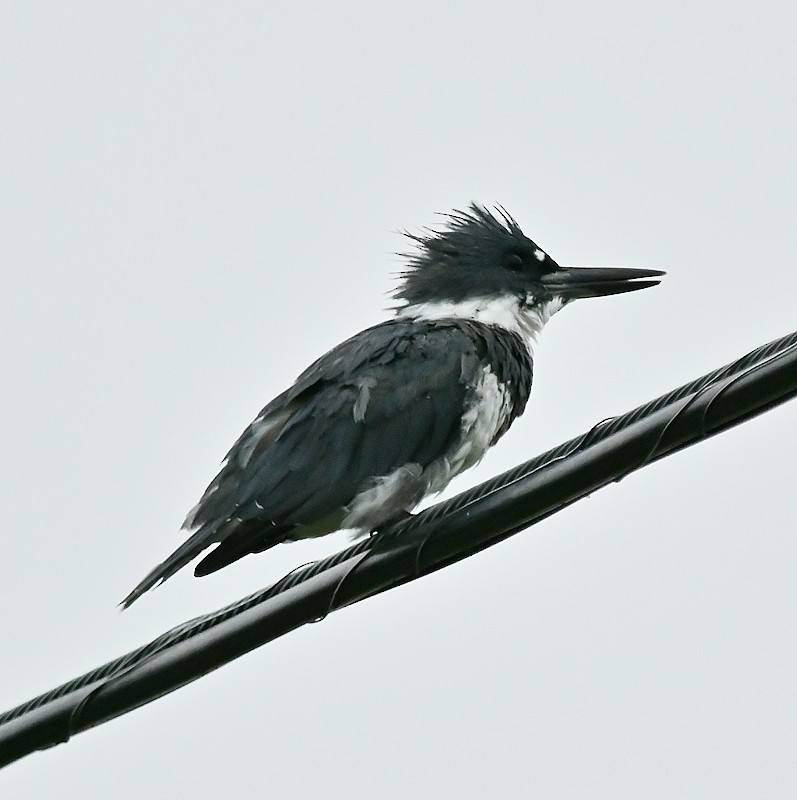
122,204,664,607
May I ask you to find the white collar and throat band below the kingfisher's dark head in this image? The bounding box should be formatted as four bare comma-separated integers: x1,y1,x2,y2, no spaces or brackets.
397,295,565,351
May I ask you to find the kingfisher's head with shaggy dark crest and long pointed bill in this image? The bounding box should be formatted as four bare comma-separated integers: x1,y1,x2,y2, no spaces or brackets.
394,203,664,334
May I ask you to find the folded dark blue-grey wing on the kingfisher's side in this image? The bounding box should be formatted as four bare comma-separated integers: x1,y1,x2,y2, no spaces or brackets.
194,322,479,527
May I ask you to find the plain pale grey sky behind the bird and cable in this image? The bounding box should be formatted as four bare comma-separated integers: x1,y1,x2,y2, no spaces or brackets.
0,0,797,800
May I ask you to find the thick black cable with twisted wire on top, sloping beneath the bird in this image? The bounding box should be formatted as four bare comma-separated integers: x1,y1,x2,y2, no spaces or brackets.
0,332,797,766
